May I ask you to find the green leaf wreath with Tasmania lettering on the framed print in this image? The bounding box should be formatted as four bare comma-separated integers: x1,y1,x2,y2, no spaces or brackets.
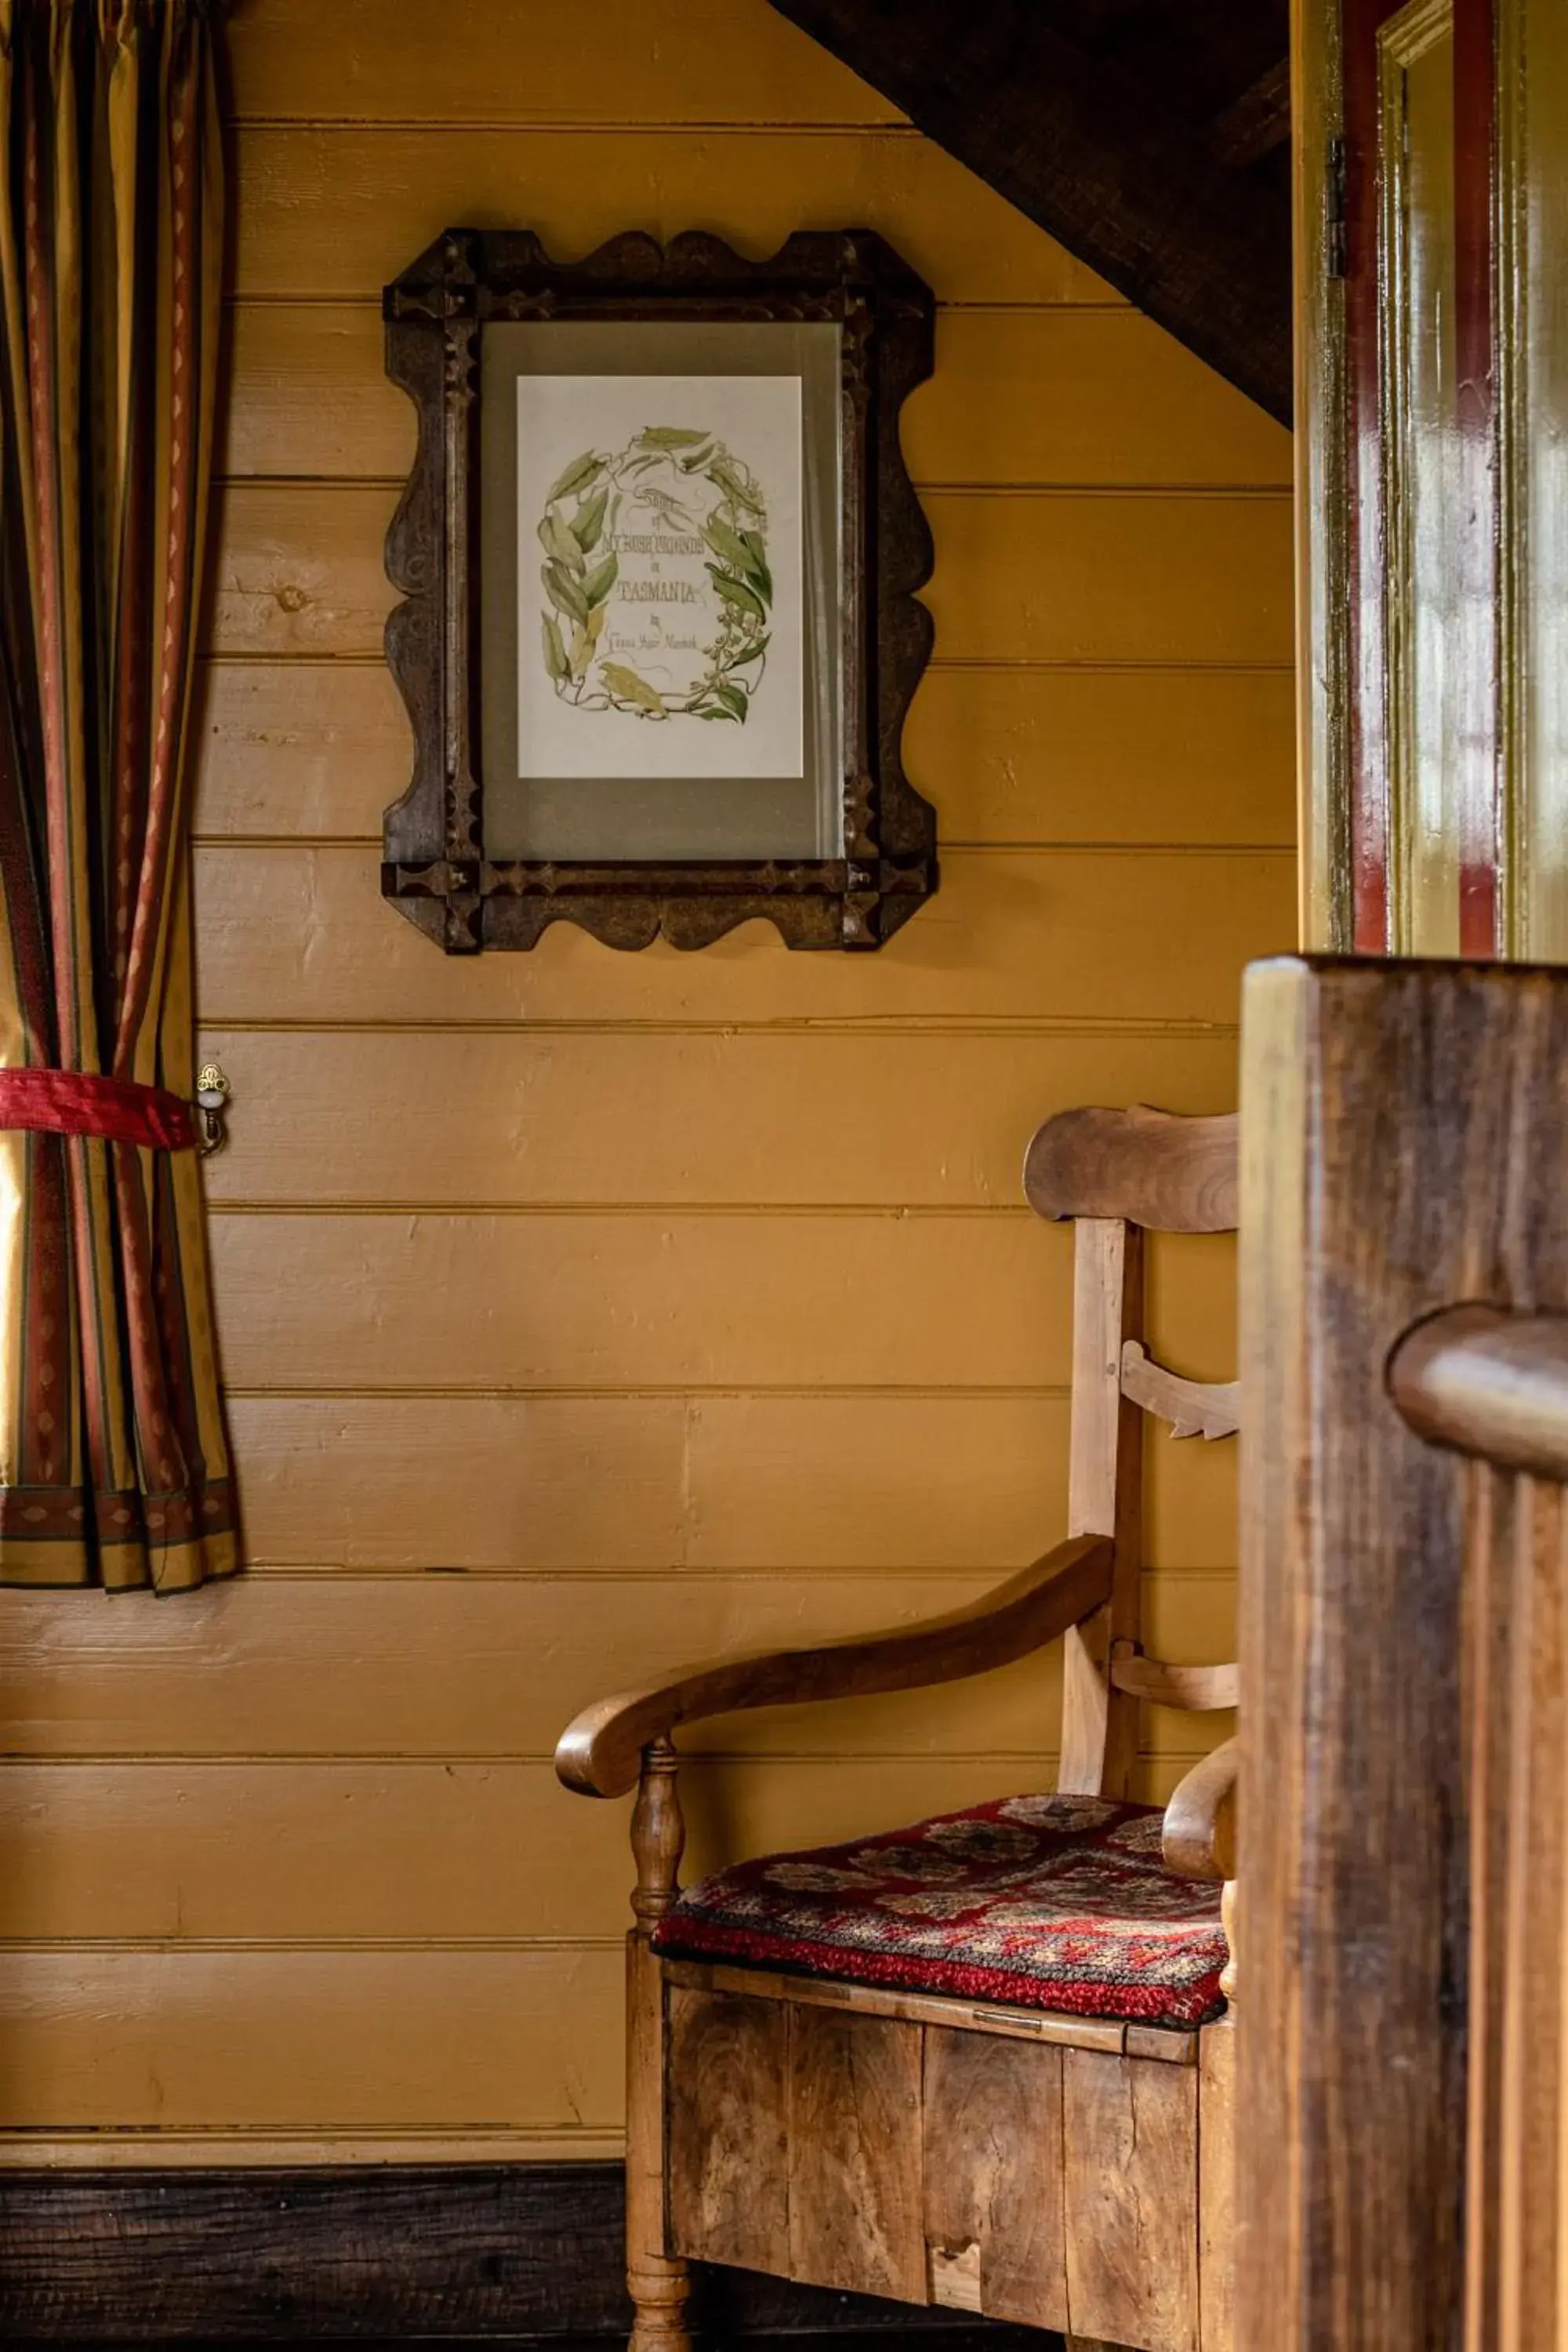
539,426,774,727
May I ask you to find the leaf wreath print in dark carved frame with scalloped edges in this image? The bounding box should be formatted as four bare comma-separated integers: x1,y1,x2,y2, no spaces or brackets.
383,230,938,953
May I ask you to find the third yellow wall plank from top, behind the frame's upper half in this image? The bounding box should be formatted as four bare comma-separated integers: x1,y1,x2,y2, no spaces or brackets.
221,301,1290,489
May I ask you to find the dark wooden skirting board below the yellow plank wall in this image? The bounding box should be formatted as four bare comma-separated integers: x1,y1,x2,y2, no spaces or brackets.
0,2164,1058,2352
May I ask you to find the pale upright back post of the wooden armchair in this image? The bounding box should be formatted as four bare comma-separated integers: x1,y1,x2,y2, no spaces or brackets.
1055,1216,1142,1797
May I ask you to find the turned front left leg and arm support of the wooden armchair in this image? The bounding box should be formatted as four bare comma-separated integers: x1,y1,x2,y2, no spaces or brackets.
626,1740,691,2352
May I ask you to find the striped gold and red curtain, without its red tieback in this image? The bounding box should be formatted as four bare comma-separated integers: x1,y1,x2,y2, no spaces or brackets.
0,0,240,1592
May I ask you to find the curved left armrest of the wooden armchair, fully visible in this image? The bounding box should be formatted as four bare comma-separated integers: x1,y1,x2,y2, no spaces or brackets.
555,1536,1116,1797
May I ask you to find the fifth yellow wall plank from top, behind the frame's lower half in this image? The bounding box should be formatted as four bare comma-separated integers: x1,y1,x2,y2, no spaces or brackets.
195,659,1295,849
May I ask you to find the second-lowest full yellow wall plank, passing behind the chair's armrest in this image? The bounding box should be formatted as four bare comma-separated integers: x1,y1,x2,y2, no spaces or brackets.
0,1750,1225,1947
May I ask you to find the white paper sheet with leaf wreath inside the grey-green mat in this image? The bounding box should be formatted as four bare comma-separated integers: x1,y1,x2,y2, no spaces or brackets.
515,374,806,781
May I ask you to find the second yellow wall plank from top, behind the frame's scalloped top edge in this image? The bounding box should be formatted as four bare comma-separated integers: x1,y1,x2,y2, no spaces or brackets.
235,124,1119,303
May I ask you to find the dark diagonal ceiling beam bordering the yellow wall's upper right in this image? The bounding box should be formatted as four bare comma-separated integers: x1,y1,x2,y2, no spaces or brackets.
771,0,1290,423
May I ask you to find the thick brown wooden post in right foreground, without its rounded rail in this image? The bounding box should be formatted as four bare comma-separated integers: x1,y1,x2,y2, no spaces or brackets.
1236,960,1568,2352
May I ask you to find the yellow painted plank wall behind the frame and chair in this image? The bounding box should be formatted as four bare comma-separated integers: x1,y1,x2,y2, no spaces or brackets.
0,0,1295,2164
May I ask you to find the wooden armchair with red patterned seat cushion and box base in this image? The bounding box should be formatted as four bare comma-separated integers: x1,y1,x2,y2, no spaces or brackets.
555,1110,1236,2352
